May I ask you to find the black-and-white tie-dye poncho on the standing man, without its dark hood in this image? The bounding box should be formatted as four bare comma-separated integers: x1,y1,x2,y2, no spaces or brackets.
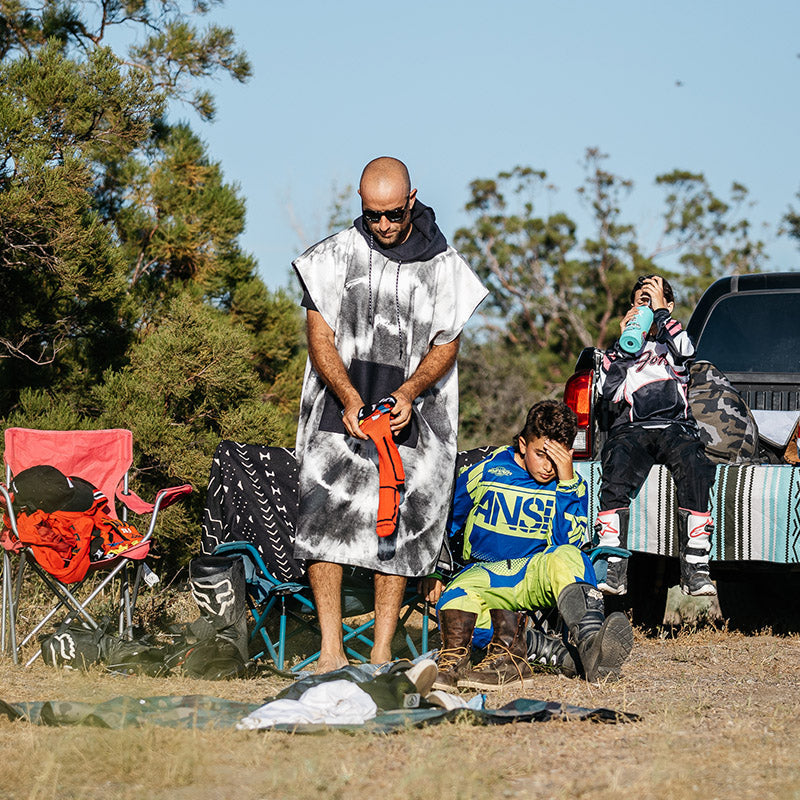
294,219,487,577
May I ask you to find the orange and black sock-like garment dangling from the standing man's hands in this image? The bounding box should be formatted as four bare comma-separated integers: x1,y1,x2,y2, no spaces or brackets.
358,397,406,537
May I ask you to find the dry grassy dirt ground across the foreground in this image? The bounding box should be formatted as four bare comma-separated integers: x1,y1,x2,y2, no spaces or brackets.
0,629,800,800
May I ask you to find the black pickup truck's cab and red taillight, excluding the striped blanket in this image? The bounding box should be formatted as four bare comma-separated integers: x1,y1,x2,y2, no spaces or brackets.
564,272,800,462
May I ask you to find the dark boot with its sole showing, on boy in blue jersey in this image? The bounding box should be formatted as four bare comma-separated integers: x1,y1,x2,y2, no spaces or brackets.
558,583,633,683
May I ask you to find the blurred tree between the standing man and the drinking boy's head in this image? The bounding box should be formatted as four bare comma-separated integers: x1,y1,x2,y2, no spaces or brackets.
455,149,645,395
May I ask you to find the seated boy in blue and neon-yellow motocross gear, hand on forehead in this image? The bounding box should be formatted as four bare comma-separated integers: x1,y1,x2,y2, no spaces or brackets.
428,400,633,689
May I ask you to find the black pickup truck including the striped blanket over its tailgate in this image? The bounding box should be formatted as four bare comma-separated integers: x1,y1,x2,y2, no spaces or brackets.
564,271,800,632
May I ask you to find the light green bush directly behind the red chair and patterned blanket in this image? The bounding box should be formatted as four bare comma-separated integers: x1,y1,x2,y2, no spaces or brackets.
90,293,293,566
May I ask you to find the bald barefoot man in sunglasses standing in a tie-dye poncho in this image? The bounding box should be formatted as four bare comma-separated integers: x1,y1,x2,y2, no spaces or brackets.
293,157,487,672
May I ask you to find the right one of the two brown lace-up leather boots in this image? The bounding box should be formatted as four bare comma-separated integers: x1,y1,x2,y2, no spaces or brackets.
458,608,533,689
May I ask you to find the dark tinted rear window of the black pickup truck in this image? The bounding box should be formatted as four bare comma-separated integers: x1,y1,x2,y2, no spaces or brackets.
696,292,800,372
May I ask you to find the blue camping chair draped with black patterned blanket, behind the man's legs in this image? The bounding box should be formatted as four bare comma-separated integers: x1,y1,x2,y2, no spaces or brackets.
201,440,435,672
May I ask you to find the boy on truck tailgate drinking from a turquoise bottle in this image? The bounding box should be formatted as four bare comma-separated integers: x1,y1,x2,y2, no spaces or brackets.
595,275,717,595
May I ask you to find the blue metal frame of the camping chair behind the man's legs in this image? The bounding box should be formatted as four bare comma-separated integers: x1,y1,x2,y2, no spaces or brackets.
214,541,435,672
